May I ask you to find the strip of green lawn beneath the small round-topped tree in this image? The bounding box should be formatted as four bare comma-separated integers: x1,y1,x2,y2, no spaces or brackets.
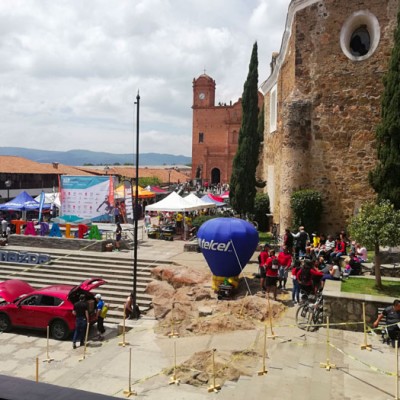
341,278,400,297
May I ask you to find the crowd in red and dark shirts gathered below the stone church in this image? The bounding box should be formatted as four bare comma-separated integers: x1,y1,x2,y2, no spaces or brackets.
258,226,368,304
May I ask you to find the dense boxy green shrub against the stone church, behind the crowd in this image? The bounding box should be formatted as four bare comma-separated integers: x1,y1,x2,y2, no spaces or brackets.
290,189,322,232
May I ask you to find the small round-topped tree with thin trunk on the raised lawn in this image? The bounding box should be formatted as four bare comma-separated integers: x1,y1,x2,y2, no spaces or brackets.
348,200,400,288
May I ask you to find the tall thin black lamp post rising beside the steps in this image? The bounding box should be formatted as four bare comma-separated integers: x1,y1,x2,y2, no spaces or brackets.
131,91,140,319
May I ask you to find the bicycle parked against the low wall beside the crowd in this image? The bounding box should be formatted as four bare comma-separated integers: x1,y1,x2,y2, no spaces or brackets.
296,293,324,332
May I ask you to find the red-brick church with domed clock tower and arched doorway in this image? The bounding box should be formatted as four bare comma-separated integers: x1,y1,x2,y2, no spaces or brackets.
192,74,242,184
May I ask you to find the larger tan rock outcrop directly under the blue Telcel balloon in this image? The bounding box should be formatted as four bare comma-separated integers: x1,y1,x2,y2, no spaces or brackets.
146,266,285,336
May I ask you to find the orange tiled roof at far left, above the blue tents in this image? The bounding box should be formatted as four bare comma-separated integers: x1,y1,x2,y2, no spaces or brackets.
0,156,93,175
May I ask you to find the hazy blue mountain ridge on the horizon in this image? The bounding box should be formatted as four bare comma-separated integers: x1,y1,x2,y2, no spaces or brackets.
0,147,192,166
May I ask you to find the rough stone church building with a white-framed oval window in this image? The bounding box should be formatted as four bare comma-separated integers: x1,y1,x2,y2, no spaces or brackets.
258,0,399,234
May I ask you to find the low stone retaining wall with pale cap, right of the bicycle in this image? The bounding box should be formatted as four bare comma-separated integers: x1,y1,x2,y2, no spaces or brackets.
323,277,395,331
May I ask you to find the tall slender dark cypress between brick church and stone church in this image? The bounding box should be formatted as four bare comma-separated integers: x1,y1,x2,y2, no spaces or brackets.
229,42,260,216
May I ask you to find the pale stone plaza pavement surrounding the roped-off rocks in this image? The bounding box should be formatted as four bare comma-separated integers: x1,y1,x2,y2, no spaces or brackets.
0,239,396,400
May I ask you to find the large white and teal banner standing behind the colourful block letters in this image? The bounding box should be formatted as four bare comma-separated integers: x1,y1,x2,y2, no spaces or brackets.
60,175,114,222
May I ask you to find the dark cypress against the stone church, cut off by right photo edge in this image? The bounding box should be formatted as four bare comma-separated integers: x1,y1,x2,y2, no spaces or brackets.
369,10,400,210
